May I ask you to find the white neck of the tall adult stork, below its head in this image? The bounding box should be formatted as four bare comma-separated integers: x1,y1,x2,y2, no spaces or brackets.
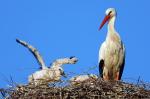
107,16,120,40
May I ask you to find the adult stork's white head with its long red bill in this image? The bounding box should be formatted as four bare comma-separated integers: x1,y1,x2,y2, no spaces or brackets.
99,8,116,30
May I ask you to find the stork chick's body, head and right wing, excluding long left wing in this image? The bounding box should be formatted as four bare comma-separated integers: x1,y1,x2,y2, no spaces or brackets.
28,57,77,85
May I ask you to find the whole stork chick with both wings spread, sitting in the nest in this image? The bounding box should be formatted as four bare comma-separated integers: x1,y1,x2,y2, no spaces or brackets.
16,39,78,85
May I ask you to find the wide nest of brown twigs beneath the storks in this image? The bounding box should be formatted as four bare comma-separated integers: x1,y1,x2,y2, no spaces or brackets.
1,79,150,99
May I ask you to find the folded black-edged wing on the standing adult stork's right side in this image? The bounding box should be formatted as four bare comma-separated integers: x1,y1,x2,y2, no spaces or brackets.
119,44,125,80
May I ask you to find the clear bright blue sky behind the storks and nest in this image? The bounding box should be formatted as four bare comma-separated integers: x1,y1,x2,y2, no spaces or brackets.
0,0,150,87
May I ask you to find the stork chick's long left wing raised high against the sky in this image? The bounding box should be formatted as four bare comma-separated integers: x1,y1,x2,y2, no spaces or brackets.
16,39,47,69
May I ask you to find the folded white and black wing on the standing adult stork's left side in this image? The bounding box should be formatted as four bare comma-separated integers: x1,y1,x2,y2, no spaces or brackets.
99,42,105,78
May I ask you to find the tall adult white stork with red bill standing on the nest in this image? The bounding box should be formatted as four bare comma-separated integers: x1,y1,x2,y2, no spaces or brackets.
99,8,125,81
